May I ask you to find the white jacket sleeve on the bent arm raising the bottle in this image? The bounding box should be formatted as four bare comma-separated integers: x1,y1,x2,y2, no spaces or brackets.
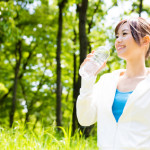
76,77,104,126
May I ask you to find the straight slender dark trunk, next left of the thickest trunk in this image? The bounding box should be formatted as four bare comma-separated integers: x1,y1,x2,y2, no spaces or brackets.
56,0,67,126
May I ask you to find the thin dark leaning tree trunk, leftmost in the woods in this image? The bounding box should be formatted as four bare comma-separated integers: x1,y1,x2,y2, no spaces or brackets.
10,41,22,127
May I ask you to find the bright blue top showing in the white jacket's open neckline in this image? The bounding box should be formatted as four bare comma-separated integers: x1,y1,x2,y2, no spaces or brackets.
112,89,133,122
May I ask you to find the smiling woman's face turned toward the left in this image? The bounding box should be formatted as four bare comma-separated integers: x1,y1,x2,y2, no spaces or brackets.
115,22,145,60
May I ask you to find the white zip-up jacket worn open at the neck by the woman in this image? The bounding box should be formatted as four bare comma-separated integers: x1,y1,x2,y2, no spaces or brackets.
77,70,150,150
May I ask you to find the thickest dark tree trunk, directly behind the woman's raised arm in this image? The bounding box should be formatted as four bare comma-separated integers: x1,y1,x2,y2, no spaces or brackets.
72,0,88,134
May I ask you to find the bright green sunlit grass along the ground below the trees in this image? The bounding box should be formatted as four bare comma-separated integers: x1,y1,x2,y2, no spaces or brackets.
0,125,98,150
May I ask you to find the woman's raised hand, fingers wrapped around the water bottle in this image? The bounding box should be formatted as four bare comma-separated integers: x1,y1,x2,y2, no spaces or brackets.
80,50,107,75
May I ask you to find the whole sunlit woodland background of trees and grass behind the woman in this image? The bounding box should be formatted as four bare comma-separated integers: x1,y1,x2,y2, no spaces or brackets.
0,0,150,150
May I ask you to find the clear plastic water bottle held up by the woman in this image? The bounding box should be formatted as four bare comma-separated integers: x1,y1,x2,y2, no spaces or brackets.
79,46,110,78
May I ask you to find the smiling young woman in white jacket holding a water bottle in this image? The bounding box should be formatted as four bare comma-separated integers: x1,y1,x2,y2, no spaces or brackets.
77,17,150,150
